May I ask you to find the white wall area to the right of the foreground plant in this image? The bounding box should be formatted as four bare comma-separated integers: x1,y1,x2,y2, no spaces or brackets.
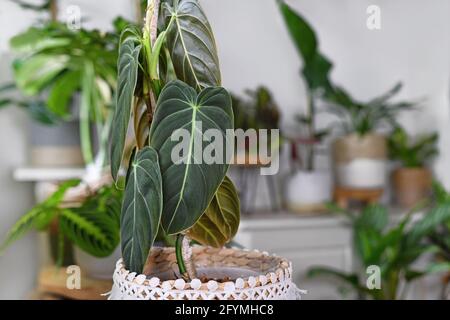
202,0,450,188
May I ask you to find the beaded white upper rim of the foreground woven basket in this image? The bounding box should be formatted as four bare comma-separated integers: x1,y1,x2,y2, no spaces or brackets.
113,246,292,292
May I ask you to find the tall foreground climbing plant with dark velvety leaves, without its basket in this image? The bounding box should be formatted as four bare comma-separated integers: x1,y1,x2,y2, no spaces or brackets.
111,0,239,279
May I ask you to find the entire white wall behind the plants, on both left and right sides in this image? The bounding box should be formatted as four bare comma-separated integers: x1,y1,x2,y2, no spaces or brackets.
0,0,450,298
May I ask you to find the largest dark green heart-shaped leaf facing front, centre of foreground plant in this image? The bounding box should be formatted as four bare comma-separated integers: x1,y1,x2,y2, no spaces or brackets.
150,81,233,234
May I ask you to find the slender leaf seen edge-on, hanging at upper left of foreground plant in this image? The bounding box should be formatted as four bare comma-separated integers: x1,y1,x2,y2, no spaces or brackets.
111,30,142,181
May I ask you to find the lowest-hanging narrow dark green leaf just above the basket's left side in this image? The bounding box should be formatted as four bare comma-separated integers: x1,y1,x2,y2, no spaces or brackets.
120,147,162,273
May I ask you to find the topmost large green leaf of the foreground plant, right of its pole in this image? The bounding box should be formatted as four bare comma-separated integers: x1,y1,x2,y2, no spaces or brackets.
160,0,221,91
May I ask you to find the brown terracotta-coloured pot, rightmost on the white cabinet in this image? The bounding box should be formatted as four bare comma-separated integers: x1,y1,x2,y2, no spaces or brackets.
392,168,433,208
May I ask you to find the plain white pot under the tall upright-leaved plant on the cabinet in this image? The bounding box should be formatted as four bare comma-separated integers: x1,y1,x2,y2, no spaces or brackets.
286,170,332,212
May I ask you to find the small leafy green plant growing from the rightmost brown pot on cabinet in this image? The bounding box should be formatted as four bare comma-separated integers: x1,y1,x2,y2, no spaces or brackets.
388,127,439,168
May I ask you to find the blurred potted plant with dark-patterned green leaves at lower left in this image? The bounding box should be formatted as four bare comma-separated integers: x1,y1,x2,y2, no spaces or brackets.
0,180,122,278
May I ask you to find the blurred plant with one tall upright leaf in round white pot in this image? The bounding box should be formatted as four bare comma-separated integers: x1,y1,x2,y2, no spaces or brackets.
278,0,332,213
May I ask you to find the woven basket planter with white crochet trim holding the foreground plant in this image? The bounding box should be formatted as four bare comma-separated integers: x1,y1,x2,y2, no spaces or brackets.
109,246,304,300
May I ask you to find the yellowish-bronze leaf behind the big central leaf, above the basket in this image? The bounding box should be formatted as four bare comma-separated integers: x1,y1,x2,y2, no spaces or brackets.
188,177,240,248
